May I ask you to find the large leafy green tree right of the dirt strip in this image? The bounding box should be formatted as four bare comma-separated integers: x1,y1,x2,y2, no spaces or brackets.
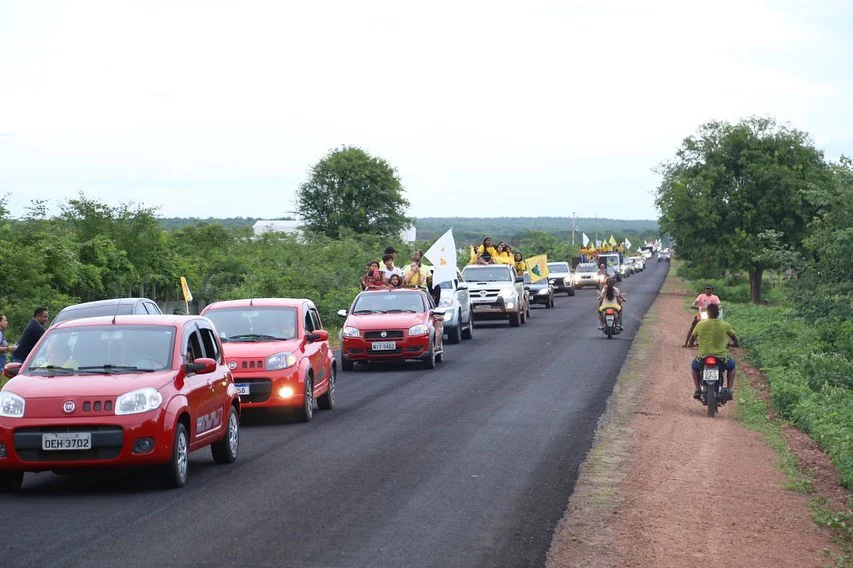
656,117,828,303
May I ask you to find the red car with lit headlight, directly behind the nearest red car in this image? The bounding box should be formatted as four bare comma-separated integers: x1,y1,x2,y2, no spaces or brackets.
202,298,337,422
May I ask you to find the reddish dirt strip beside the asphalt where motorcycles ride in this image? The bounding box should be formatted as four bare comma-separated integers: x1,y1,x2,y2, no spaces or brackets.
547,270,837,568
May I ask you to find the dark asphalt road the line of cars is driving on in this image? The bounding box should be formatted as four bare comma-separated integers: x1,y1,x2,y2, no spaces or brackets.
0,260,669,568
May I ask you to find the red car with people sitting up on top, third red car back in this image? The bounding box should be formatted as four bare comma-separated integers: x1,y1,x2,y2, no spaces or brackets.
338,289,444,371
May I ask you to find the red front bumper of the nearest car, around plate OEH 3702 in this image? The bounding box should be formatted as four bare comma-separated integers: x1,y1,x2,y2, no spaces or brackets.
0,409,175,471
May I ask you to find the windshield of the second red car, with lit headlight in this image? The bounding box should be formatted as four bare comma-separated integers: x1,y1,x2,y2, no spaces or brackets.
204,306,298,342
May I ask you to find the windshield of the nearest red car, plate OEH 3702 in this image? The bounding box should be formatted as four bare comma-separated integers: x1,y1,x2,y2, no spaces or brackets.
22,325,175,375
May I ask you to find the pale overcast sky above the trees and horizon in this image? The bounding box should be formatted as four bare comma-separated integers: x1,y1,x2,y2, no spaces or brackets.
0,0,853,219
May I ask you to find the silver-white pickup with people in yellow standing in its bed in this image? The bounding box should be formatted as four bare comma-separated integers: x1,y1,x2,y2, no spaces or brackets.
462,264,530,327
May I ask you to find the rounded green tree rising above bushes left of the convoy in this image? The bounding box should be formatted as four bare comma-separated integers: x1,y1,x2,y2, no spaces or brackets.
297,146,410,238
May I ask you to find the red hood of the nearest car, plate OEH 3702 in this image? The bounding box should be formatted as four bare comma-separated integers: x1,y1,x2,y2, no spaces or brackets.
3,370,176,399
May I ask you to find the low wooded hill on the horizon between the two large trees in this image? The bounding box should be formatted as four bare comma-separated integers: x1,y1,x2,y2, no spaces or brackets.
415,217,660,242
